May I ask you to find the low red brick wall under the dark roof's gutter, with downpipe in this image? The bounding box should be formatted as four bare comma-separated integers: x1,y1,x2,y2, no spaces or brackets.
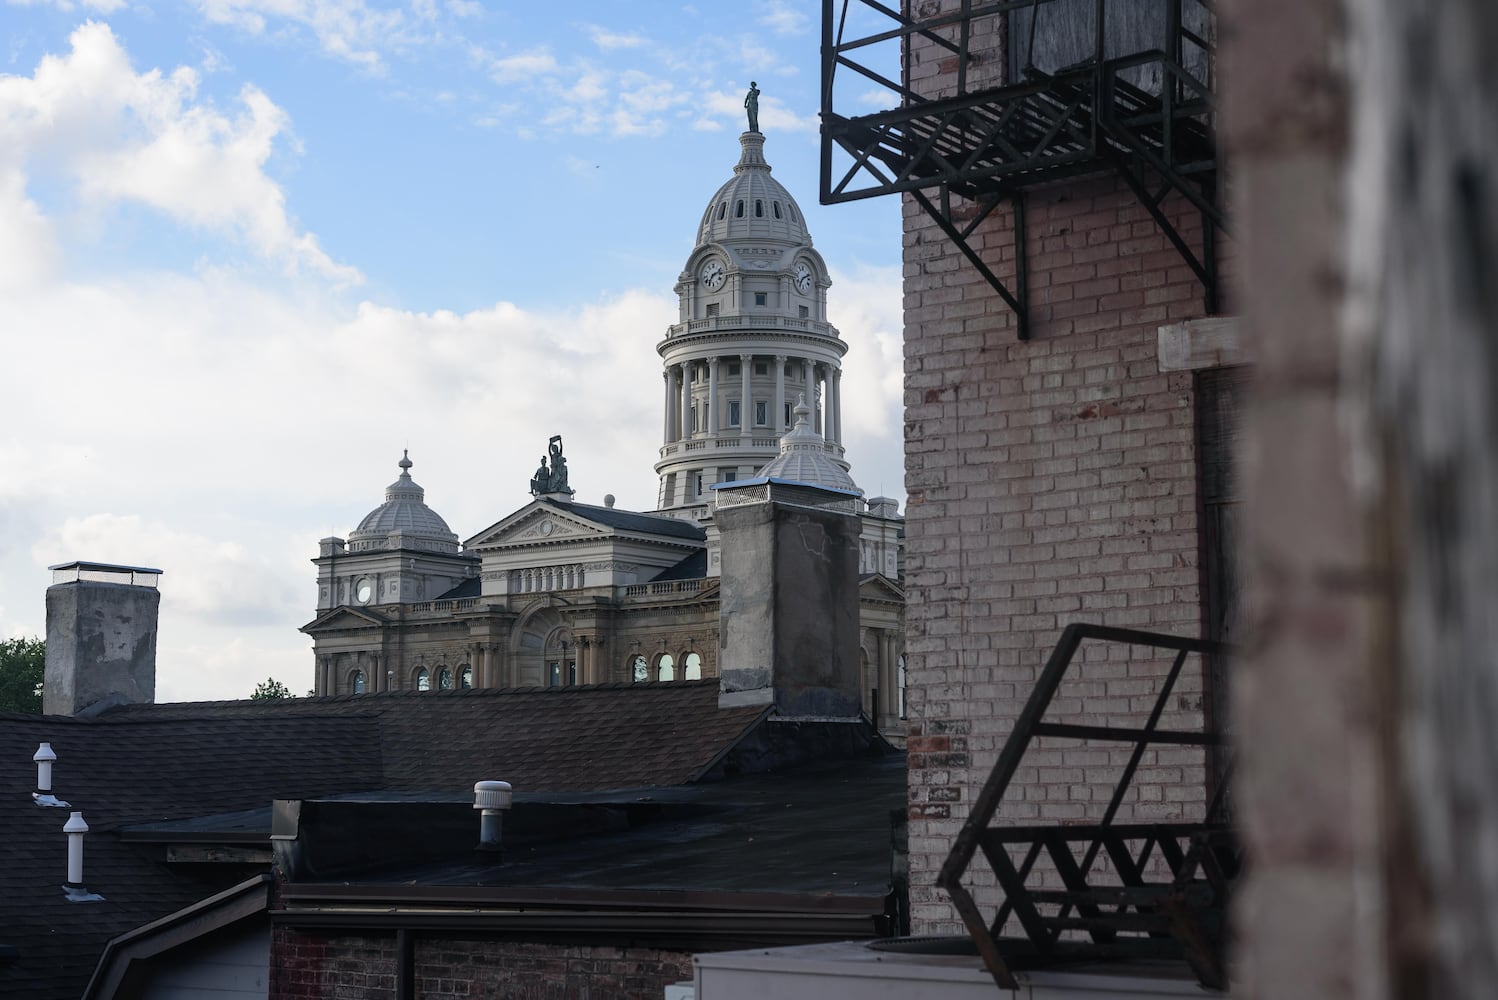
270,927,692,1000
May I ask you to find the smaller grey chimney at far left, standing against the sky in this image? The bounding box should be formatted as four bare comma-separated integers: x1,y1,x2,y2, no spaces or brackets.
42,561,162,716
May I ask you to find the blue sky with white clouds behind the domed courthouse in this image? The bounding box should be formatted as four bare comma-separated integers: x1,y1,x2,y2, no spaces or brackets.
0,0,905,701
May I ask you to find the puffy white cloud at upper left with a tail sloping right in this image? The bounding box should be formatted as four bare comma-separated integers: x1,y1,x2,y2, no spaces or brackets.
0,22,358,283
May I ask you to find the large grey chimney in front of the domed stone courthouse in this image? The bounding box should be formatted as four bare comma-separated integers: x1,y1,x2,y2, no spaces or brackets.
713,478,863,720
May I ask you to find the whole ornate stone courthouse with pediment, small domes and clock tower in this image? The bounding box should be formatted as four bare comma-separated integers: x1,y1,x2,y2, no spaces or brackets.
303,133,905,740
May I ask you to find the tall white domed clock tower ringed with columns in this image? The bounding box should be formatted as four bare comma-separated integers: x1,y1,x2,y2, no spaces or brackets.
656,132,848,516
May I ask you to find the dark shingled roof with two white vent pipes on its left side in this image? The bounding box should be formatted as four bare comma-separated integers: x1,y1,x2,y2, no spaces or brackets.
0,681,762,1000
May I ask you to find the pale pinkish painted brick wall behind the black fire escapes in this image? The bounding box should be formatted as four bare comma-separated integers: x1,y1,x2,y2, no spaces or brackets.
903,7,1222,934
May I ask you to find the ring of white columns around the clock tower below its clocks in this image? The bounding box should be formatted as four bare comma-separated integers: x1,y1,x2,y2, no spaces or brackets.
661,355,842,445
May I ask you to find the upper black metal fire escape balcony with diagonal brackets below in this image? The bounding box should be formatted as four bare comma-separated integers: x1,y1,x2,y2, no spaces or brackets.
821,0,1224,340
